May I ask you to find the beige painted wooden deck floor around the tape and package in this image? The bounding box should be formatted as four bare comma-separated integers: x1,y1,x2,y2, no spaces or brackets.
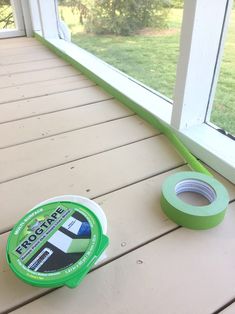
0,38,235,314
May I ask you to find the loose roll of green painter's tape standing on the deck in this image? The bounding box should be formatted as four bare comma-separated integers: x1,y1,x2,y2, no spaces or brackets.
161,171,229,229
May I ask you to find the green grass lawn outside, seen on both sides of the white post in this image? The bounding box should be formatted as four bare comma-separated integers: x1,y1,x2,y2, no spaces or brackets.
61,8,235,134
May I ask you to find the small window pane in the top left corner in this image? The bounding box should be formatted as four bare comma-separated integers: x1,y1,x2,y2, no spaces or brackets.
0,0,15,29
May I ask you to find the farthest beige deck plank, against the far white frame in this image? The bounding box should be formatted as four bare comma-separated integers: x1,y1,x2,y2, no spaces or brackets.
0,37,41,50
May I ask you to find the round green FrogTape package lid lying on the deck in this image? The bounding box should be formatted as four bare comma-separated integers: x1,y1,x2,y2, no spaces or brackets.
7,201,108,287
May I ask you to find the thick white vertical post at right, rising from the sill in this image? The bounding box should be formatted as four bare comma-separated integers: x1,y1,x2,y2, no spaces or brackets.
171,0,230,130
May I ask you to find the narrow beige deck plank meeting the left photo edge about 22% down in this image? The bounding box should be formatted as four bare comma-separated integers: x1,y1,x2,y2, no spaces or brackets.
0,58,68,75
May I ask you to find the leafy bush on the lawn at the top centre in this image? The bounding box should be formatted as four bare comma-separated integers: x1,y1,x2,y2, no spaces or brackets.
85,0,169,35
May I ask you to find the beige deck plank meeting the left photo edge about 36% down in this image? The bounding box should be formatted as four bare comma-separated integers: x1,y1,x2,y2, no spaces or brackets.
0,86,112,123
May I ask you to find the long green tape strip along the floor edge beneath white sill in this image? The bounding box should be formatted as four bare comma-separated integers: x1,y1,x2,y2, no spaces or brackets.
34,33,212,176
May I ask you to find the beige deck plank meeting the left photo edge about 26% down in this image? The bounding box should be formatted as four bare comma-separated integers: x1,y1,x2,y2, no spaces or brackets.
0,65,80,88
